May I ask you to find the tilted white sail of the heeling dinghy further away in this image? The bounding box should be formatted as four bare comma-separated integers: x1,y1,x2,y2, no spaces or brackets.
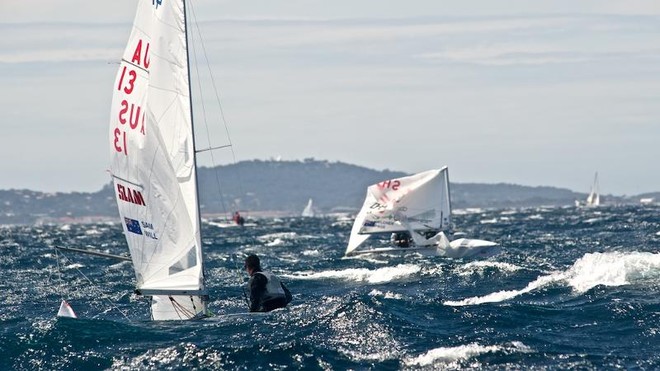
346,166,451,255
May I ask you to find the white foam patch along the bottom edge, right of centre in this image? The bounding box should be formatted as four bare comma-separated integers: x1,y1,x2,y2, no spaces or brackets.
404,342,531,366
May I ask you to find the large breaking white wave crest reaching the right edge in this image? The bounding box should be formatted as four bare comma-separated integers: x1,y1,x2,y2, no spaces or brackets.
444,252,660,306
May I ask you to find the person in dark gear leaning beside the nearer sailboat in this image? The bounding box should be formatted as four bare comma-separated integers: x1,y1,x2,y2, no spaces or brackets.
245,254,292,312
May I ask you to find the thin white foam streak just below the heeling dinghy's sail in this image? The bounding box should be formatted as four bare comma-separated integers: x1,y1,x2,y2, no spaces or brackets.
283,264,421,283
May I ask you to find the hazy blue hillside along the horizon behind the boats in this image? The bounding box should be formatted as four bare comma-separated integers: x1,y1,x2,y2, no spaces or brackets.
0,159,636,224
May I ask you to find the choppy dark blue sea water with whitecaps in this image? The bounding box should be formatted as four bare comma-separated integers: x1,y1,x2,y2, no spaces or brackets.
0,206,660,370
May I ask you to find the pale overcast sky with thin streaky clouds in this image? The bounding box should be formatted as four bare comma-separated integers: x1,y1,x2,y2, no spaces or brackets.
0,0,660,195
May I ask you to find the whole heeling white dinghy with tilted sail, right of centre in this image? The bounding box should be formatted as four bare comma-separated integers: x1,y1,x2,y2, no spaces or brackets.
345,166,498,258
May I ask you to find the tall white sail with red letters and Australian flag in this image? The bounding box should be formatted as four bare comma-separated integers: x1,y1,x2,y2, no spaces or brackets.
110,0,206,320
